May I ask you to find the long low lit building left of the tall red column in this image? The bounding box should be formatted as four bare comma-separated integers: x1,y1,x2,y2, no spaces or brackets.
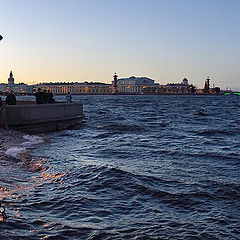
34,82,112,95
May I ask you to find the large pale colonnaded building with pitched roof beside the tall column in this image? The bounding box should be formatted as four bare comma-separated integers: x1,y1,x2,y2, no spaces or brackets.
112,76,159,94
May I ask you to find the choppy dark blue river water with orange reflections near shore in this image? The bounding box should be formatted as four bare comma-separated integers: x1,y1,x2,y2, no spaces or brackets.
0,96,240,239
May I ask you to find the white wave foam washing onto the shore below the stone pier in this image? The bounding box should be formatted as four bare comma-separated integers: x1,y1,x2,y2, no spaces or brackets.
5,135,44,159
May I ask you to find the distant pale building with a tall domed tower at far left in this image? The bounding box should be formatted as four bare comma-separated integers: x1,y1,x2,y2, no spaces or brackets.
0,71,33,94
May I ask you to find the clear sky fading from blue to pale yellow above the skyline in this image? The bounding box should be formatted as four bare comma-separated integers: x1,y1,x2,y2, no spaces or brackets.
0,0,240,90
